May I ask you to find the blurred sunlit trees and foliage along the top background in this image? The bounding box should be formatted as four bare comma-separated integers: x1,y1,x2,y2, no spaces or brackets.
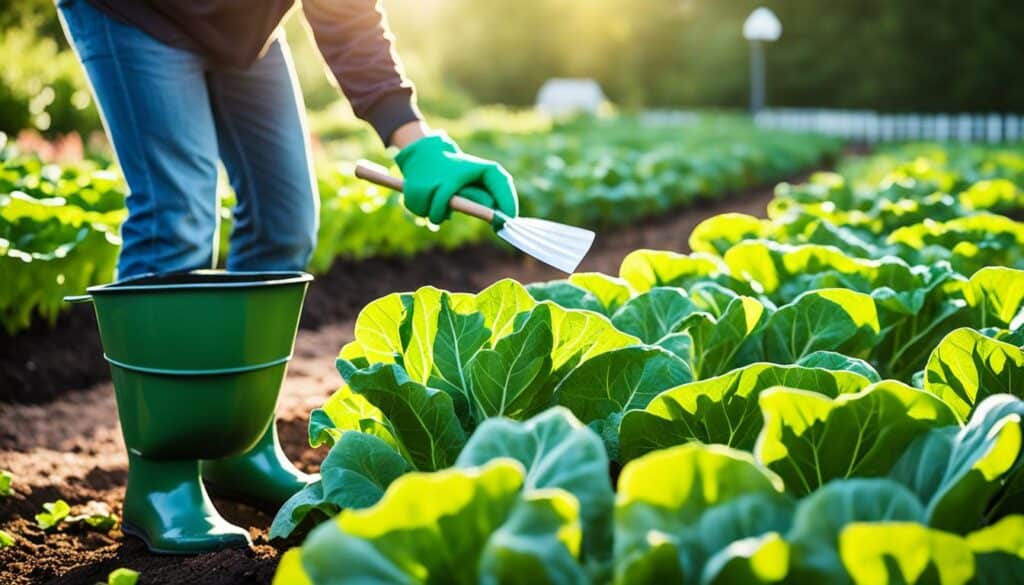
0,0,1024,134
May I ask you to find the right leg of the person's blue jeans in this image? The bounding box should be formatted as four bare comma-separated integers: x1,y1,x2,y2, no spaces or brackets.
207,40,319,270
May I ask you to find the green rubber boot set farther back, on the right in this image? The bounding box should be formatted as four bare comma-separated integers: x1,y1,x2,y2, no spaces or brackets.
202,421,317,511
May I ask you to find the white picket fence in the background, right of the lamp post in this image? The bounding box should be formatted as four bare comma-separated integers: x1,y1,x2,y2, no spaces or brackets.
755,108,1024,142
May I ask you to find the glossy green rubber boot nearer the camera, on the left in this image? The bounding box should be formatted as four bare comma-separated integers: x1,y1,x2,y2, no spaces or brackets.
123,452,252,554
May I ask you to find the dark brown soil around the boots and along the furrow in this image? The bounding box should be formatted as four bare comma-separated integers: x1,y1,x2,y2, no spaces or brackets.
0,179,790,585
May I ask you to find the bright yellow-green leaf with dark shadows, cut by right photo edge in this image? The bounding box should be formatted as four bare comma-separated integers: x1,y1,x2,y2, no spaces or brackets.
925,328,1024,420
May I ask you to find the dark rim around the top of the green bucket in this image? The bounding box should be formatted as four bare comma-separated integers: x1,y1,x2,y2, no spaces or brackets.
86,270,313,295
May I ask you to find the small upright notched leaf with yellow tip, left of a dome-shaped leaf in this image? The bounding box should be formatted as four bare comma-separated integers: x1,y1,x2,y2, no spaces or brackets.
680,296,765,380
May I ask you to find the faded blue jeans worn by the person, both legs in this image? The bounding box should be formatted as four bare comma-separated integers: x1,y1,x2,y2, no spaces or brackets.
57,0,318,279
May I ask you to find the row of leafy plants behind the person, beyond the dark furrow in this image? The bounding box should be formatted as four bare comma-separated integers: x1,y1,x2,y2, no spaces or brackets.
0,115,837,333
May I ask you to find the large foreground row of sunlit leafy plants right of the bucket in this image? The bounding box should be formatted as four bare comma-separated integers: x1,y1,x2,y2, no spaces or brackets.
271,144,1024,584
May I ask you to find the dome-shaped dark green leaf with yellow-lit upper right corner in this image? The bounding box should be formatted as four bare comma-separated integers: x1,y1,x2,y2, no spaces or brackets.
740,289,880,364
